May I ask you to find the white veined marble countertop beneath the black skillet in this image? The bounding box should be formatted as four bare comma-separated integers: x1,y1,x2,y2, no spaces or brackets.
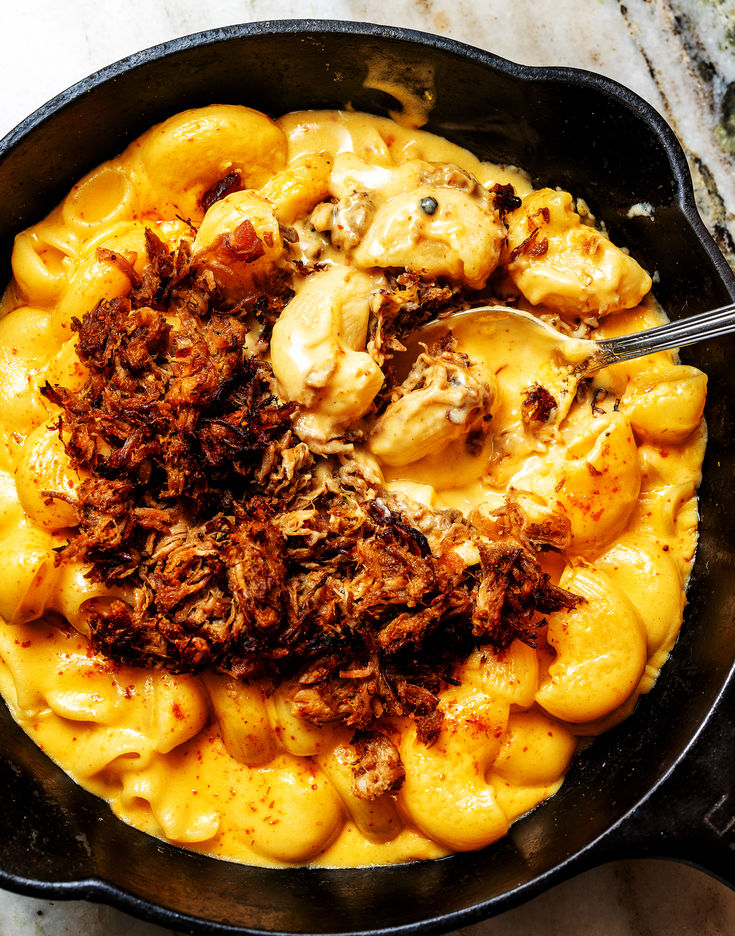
0,0,735,936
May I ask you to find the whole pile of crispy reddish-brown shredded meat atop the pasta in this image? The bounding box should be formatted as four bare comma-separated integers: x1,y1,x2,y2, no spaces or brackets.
43,227,581,798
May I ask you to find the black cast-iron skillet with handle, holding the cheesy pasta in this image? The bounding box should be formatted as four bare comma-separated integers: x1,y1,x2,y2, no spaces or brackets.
0,21,735,934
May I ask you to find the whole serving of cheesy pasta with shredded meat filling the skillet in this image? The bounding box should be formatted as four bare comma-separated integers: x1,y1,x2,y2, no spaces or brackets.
0,105,706,866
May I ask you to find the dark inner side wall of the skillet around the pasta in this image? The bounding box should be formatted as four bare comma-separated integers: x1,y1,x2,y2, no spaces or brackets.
0,23,735,932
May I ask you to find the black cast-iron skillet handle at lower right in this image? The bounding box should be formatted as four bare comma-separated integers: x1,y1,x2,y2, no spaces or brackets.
603,683,735,890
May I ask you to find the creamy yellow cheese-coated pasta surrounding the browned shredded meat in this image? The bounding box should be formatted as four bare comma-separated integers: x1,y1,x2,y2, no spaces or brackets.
0,106,706,866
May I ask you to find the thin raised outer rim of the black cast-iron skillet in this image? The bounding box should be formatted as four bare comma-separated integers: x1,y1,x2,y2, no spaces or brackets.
0,19,735,936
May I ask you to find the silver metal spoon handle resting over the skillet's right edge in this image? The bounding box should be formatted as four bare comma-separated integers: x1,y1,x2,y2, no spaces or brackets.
588,303,735,373
